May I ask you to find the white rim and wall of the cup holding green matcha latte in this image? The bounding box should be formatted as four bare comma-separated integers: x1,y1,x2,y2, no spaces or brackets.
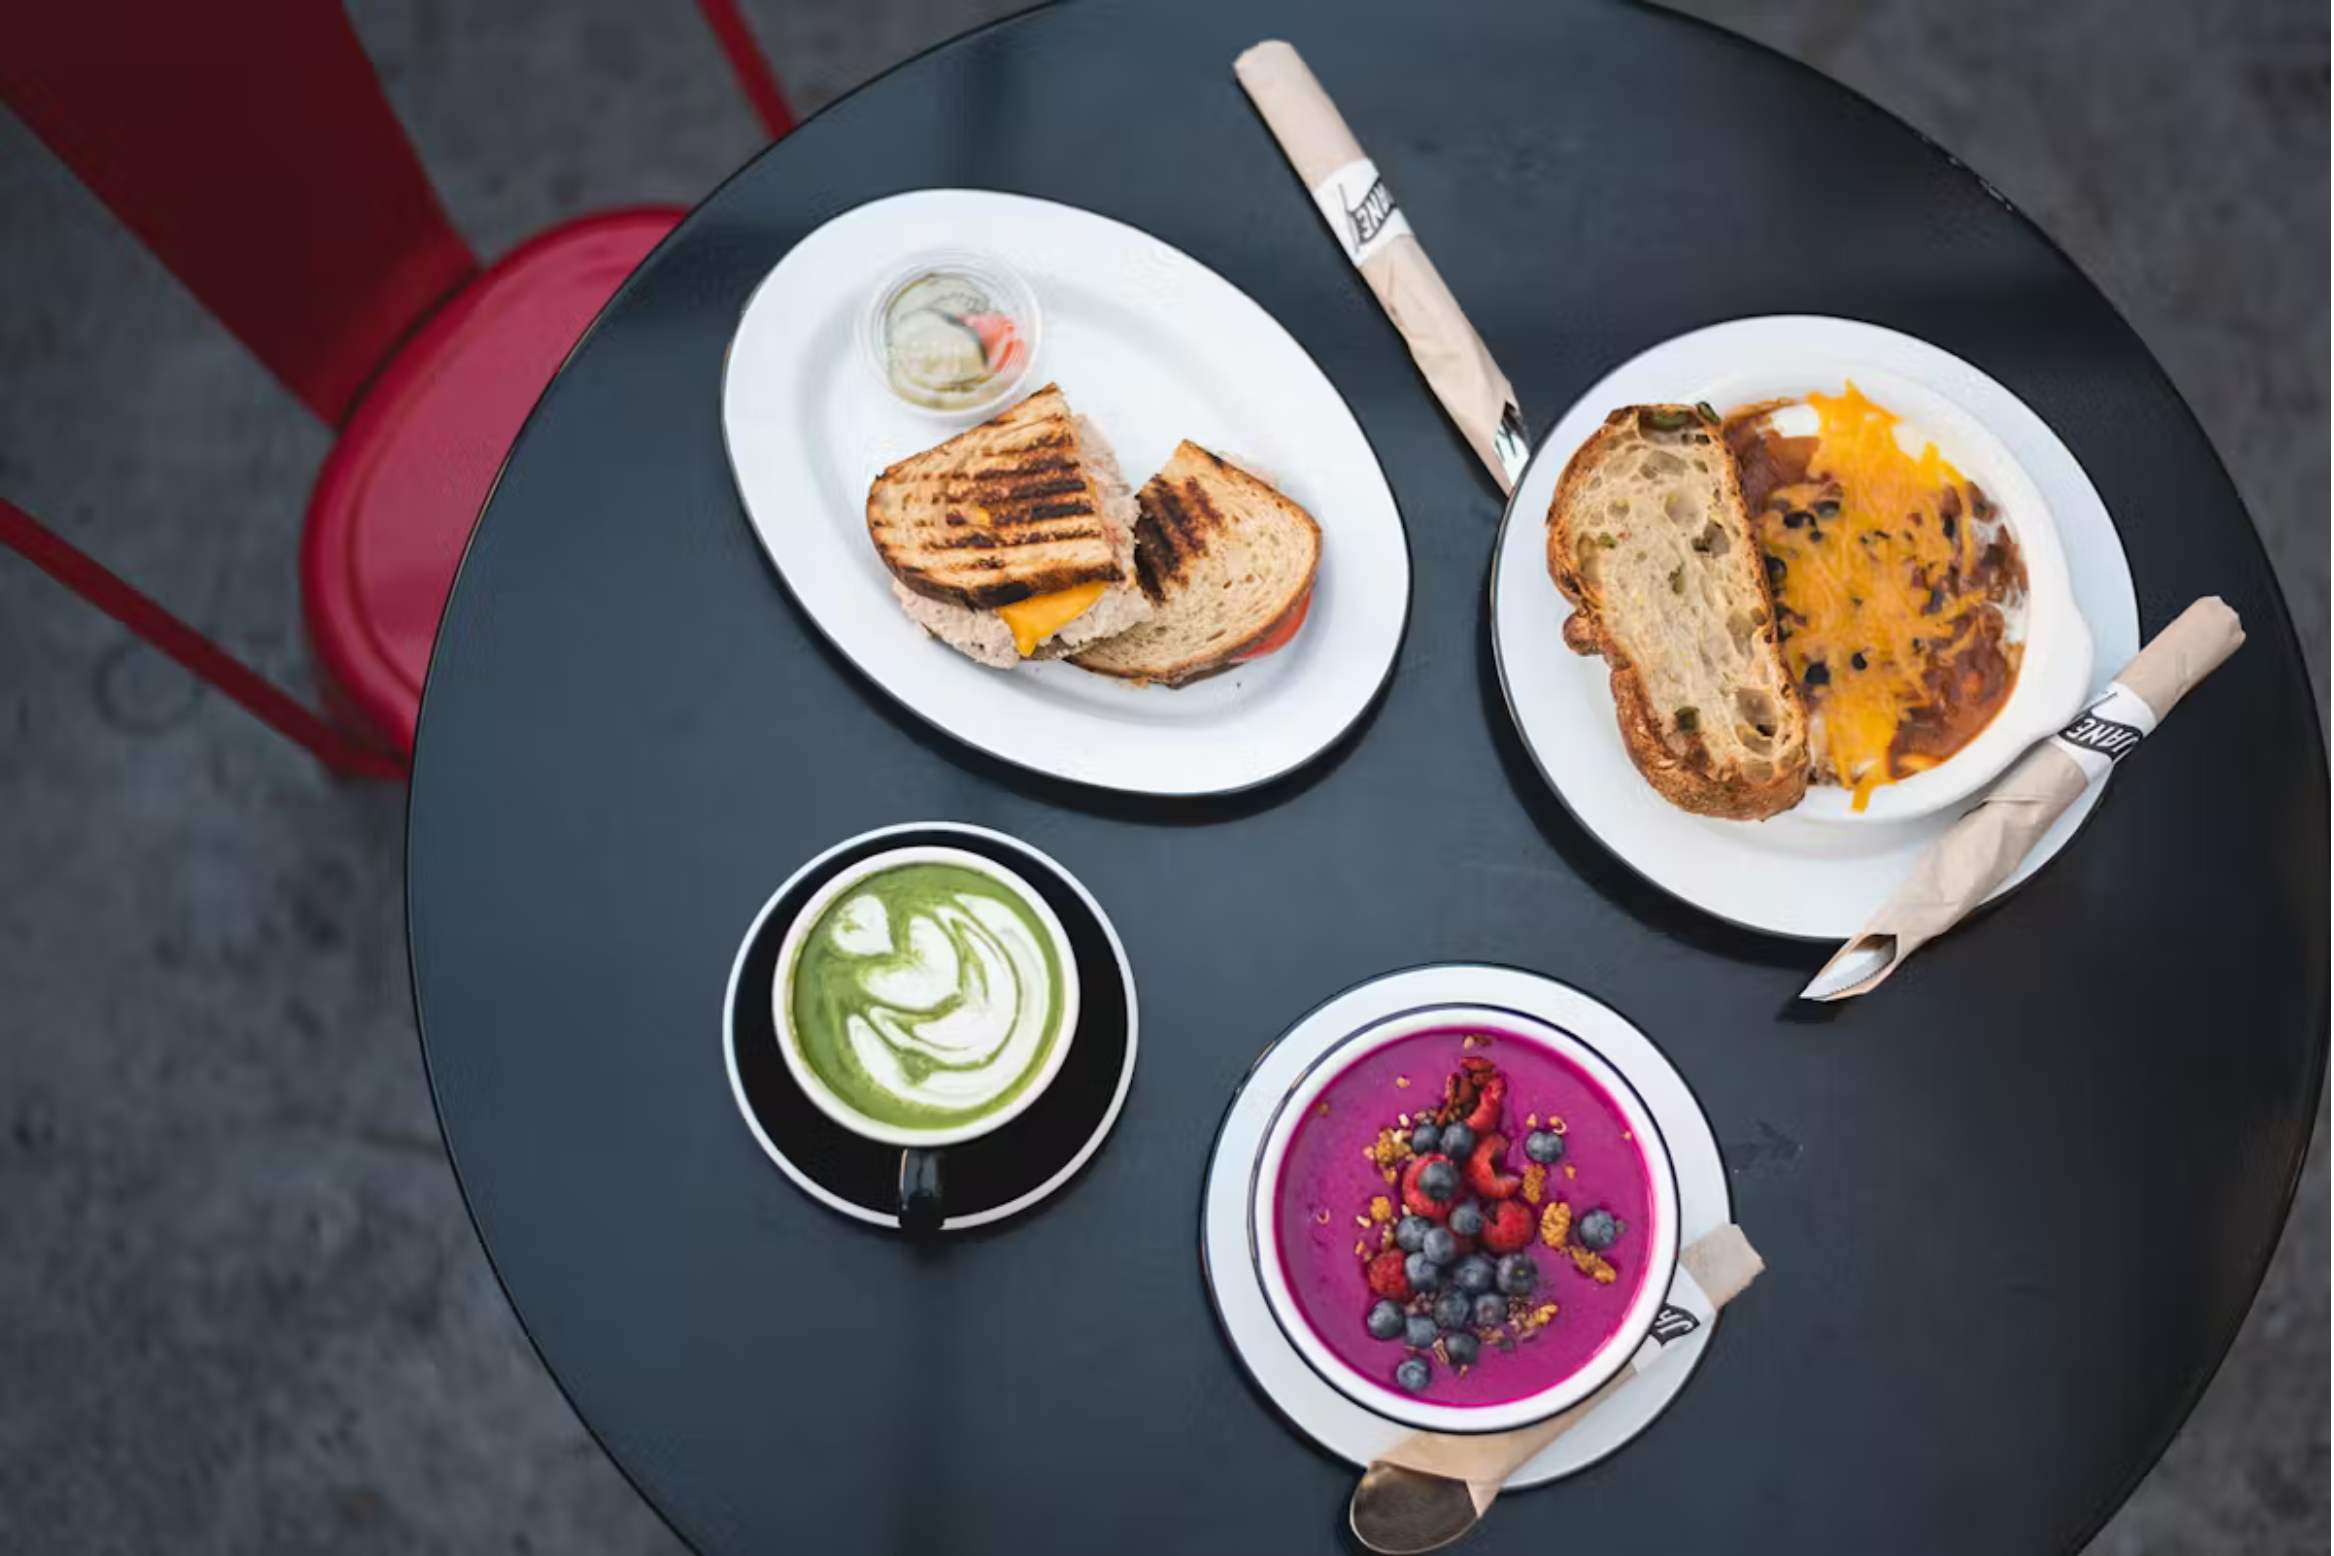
770,847,1078,1161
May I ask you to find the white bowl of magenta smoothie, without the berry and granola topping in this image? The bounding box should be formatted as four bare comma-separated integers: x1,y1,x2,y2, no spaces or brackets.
1249,1005,1678,1432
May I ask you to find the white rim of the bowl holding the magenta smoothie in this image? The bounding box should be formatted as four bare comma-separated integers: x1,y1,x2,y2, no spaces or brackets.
1249,1005,1678,1432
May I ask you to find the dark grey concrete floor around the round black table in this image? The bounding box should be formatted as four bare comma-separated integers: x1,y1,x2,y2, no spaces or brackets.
0,0,2329,1556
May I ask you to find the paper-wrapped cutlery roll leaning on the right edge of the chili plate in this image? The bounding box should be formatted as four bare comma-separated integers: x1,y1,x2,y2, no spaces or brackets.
1809,595,2245,998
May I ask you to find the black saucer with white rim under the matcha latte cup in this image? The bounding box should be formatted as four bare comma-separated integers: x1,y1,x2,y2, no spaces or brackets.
721,821,1134,1232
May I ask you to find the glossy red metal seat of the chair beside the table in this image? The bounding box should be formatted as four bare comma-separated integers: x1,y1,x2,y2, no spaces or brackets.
301,208,684,756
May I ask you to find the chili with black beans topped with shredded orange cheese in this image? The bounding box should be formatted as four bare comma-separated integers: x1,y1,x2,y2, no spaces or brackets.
1725,383,2026,809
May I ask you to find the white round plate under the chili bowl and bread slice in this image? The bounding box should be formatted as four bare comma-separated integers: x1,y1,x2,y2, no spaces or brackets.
1491,317,2140,940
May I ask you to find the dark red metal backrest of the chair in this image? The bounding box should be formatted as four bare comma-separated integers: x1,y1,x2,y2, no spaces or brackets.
0,0,478,425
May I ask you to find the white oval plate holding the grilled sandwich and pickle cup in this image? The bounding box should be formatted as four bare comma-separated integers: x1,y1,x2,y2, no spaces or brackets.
721,189,1410,795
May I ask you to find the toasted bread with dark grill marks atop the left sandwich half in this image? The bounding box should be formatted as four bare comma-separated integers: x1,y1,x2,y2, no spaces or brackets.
868,385,1127,611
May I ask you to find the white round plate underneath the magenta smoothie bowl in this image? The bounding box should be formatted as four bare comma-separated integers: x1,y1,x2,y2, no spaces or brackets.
1200,963,1734,1488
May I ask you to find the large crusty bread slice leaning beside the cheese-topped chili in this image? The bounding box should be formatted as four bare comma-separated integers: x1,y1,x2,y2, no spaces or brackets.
1547,406,1809,821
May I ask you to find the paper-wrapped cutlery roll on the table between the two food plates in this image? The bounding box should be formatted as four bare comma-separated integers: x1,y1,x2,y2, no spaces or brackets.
1232,42,1529,490
